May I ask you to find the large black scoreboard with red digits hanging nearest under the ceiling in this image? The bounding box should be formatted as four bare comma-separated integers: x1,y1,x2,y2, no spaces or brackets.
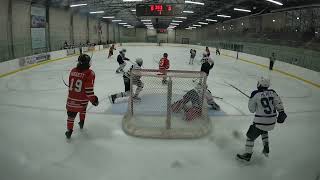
136,3,179,17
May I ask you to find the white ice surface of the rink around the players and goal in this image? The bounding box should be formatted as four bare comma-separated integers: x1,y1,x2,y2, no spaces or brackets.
0,46,320,180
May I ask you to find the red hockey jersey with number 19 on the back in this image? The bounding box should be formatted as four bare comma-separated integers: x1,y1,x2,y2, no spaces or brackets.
66,68,97,112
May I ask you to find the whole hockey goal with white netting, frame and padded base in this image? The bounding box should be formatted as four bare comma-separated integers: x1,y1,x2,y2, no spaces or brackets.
122,69,212,139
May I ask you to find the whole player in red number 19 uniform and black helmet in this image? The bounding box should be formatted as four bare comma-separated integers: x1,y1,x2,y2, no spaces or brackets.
65,54,99,139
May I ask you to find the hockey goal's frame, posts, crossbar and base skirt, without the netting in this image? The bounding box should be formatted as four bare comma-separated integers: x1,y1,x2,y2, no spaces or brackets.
122,69,212,139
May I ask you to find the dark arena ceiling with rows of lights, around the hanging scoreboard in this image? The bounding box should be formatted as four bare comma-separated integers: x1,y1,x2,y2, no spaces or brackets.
28,0,320,28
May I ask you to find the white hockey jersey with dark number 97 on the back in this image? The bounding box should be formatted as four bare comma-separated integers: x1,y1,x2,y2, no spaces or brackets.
248,89,284,131
